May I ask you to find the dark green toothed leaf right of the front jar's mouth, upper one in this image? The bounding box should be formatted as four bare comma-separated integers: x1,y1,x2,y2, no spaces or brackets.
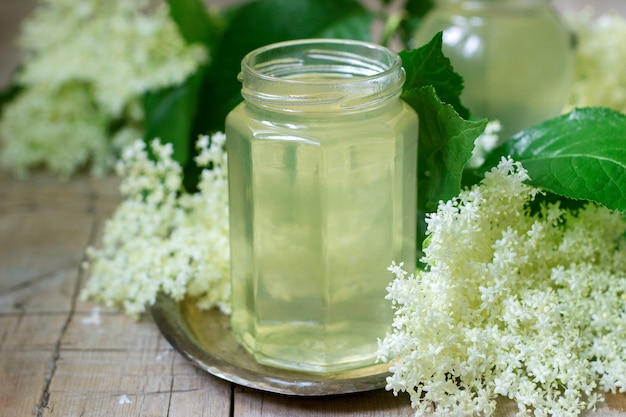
400,32,469,119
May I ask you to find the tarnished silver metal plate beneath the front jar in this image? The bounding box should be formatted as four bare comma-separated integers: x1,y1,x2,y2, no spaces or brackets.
152,296,389,396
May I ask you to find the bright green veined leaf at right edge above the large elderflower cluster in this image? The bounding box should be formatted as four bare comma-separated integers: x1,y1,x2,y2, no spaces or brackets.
485,107,626,211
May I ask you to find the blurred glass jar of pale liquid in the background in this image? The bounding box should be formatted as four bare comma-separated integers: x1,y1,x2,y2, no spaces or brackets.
411,0,574,139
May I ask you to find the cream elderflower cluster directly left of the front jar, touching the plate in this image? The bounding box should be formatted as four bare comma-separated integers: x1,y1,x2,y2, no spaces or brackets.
82,133,230,316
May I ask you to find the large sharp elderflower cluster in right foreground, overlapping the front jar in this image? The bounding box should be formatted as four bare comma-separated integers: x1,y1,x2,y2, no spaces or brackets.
378,159,626,417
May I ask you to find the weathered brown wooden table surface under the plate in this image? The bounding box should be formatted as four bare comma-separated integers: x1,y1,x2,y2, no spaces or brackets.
0,0,626,417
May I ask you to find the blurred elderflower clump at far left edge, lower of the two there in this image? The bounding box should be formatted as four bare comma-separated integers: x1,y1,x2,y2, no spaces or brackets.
0,83,112,178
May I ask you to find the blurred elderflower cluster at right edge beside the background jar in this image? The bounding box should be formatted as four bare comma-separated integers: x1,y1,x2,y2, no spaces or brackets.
568,10,626,113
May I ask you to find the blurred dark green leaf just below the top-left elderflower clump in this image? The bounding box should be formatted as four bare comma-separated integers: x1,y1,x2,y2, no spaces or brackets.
142,69,205,166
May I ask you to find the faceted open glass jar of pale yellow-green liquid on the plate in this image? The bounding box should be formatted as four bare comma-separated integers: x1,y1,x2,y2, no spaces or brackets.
226,39,417,373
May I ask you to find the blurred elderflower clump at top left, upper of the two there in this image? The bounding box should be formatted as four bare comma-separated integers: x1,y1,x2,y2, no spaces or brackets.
20,0,207,117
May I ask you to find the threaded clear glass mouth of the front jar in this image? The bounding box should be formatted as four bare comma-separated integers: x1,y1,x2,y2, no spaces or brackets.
239,39,405,112
